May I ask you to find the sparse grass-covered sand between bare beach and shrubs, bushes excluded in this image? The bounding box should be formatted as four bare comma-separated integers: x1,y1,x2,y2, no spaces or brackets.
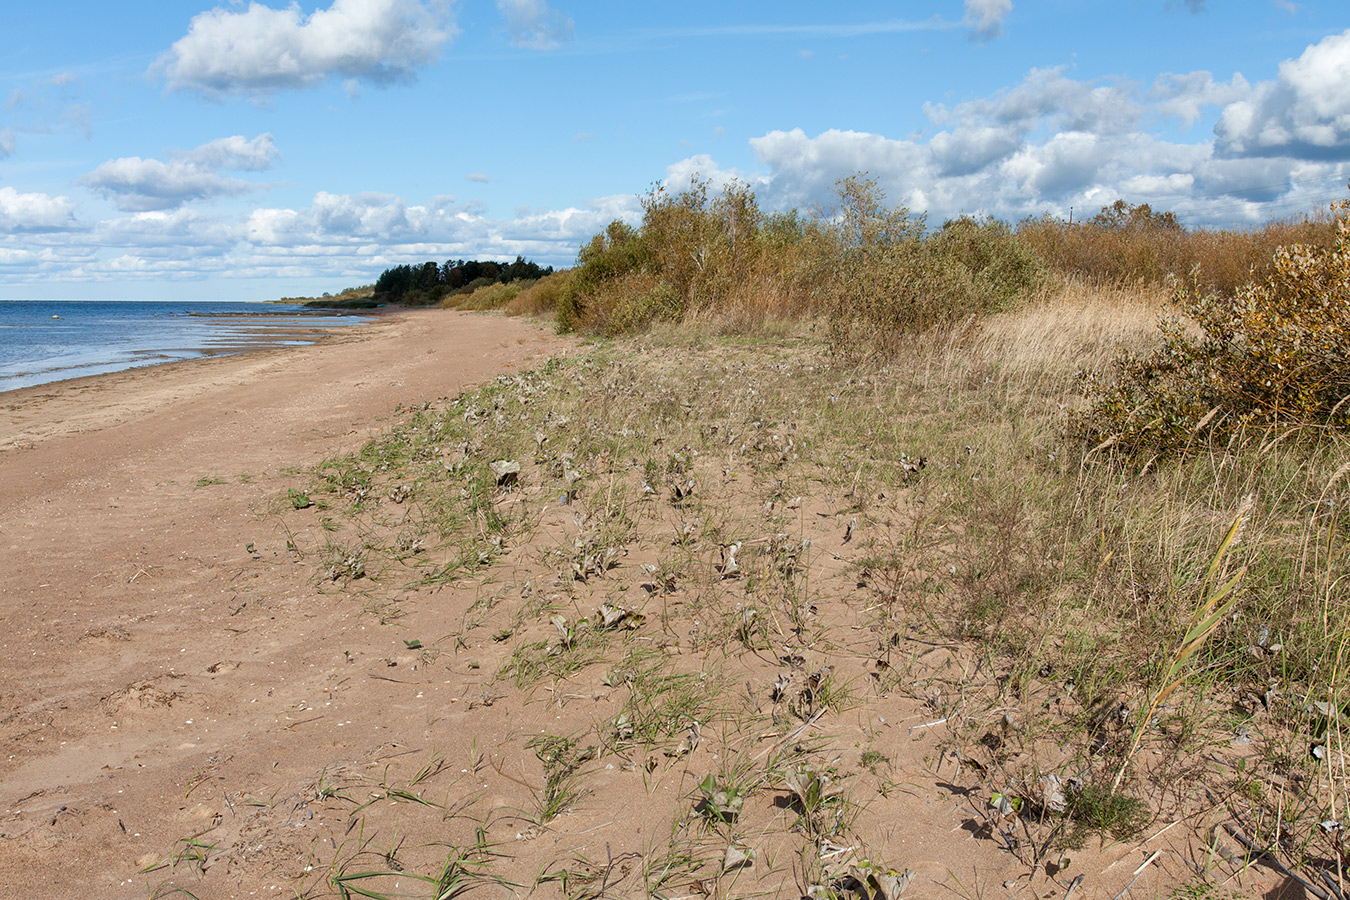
221,276,1350,896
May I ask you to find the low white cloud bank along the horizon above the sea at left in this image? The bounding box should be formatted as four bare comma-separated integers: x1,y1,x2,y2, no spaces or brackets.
0,189,641,285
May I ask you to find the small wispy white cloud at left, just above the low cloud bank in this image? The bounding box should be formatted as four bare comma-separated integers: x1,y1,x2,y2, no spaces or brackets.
80,134,279,212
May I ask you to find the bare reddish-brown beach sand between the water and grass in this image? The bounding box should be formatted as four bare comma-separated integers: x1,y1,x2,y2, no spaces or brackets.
0,310,568,900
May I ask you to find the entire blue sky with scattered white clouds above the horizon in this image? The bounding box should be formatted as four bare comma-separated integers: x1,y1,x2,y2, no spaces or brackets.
0,0,1350,300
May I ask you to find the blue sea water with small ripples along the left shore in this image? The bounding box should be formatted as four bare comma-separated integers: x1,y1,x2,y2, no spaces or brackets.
0,300,369,391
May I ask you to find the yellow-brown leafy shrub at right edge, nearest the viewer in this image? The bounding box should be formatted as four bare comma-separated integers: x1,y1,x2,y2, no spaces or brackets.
1076,192,1350,453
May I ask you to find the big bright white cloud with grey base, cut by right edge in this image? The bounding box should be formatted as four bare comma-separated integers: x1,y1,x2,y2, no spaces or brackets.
1215,30,1350,159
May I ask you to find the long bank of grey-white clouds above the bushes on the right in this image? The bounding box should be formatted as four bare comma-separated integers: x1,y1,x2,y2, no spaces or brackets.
729,40,1350,225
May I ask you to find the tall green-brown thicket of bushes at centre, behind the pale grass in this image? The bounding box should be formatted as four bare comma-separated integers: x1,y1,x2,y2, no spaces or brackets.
545,177,1042,356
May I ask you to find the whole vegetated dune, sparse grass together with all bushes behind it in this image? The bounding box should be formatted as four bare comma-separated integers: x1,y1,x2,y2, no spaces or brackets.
202,178,1350,900
